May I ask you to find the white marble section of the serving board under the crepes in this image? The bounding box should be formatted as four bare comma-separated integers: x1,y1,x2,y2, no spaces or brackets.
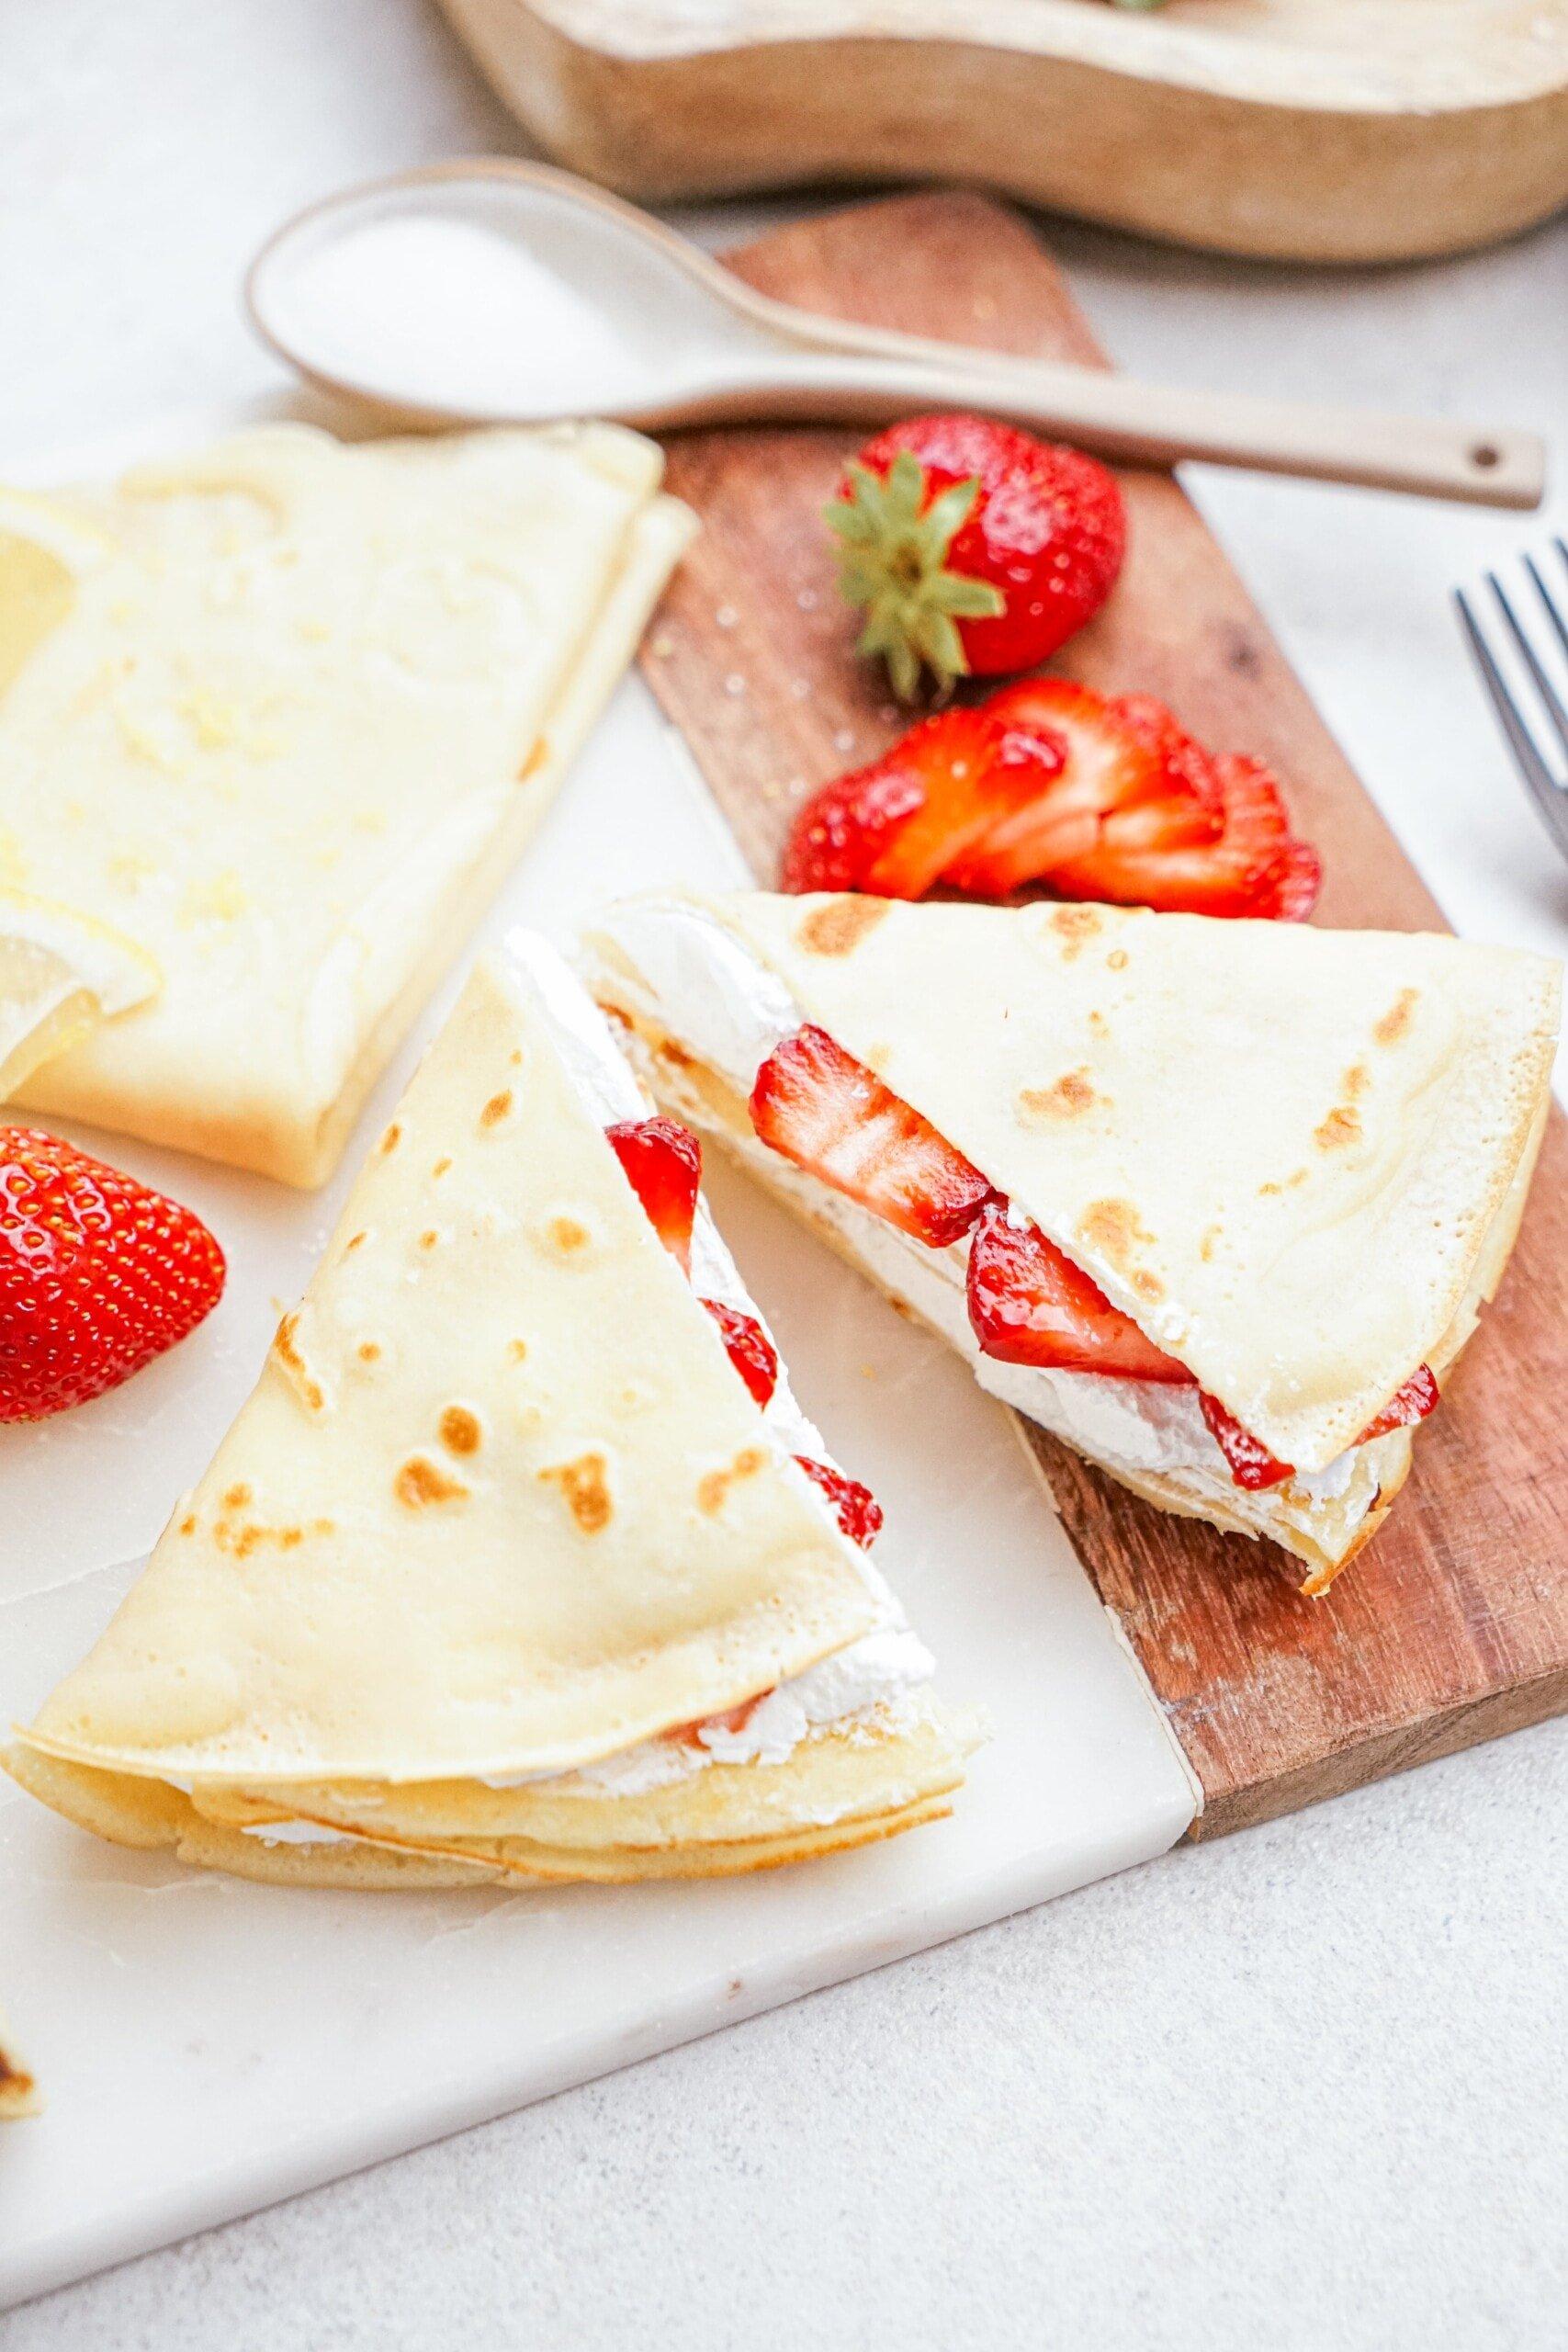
0,419,1194,2305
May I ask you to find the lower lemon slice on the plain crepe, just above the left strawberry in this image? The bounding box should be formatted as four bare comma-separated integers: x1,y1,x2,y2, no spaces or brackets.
0,889,163,1103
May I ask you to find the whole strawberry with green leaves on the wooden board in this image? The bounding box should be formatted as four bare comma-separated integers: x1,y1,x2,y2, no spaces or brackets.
828,414,1126,703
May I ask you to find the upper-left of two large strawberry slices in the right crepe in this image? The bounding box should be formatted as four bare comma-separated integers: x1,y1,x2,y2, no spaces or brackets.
750,1025,992,1249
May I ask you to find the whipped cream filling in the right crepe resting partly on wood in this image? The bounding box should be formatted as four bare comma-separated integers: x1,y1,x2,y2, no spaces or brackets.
582,899,1375,1517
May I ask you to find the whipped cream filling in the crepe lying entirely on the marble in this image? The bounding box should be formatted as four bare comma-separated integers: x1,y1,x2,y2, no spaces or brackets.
221,932,936,1847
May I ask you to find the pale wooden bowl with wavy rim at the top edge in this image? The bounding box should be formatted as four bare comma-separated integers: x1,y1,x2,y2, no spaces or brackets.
432,0,1568,261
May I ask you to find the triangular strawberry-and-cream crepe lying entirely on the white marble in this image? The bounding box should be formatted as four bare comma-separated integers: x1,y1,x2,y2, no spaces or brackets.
7,933,966,1886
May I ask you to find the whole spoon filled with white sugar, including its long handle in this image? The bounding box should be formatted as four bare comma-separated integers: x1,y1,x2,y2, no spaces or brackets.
244,158,1544,508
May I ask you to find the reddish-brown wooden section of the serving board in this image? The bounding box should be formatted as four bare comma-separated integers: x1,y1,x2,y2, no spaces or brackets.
642,193,1568,1837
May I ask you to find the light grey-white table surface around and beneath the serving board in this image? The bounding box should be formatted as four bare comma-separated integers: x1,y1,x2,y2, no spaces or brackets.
0,0,1568,2352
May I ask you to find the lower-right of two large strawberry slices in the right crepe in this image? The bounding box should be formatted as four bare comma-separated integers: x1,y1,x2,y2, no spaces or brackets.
968,1200,1192,1387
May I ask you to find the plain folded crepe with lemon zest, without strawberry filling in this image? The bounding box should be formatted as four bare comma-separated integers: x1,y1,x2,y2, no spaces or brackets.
0,425,691,1185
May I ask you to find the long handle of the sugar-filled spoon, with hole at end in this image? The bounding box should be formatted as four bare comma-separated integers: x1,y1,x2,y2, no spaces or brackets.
707,345,1547,508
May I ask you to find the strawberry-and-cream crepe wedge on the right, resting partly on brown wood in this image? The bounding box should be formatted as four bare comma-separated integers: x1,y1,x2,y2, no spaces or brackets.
588,894,1559,1590
